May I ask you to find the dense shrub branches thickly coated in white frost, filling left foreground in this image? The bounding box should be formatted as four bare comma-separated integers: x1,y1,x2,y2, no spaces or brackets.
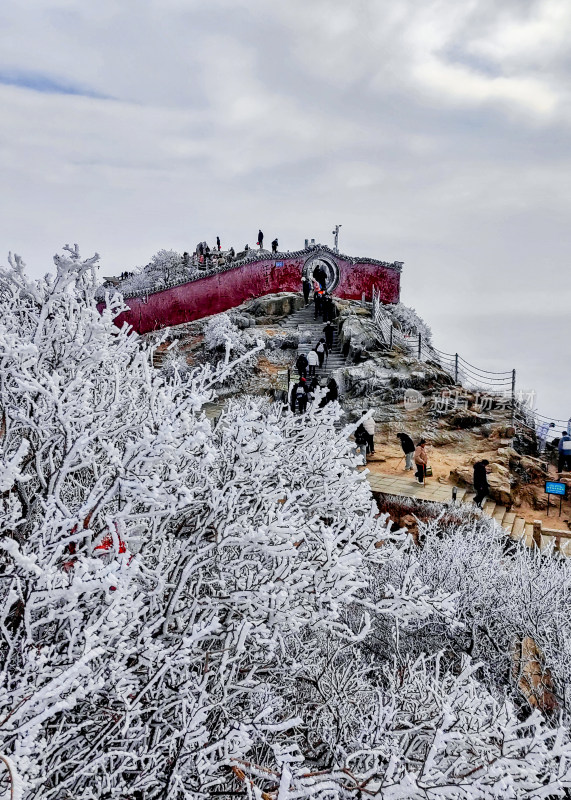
0,247,571,800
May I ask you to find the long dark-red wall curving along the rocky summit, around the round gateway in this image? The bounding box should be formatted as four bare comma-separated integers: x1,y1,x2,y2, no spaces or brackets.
106,248,400,333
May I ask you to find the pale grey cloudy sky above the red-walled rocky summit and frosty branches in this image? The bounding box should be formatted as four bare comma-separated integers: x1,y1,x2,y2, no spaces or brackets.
0,0,571,418
